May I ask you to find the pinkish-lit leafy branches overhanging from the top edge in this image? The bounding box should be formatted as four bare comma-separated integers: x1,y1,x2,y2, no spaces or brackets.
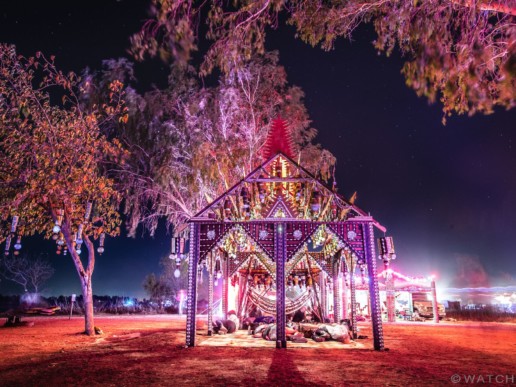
132,0,516,120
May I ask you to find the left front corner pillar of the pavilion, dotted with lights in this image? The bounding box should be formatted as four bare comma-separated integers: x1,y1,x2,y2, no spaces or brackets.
186,223,200,347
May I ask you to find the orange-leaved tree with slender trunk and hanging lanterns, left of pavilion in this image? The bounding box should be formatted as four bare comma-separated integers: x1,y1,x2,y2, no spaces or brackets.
0,45,124,335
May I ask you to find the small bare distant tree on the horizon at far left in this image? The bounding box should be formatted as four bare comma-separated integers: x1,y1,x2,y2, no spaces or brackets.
0,254,54,294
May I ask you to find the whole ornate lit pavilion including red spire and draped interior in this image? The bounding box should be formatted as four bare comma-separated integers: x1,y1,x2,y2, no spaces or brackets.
186,119,385,350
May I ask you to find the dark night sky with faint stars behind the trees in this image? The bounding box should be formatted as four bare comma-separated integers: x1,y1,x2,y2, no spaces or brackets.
0,0,516,296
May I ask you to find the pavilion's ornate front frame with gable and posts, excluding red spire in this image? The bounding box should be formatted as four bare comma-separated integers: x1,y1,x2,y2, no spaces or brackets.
186,152,385,350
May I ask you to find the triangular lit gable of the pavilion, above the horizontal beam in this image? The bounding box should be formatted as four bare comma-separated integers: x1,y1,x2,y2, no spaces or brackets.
191,152,381,227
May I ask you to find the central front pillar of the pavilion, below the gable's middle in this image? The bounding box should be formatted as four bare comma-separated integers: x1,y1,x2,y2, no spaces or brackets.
274,223,287,348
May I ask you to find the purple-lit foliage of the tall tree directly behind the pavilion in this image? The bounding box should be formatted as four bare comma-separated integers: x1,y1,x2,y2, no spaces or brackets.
100,53,335,235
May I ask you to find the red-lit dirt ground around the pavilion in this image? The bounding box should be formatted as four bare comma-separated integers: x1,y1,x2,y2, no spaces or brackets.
0,316,516,386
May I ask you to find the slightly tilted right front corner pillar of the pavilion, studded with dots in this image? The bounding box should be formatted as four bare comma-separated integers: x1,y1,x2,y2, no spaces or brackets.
364,223,384,351
